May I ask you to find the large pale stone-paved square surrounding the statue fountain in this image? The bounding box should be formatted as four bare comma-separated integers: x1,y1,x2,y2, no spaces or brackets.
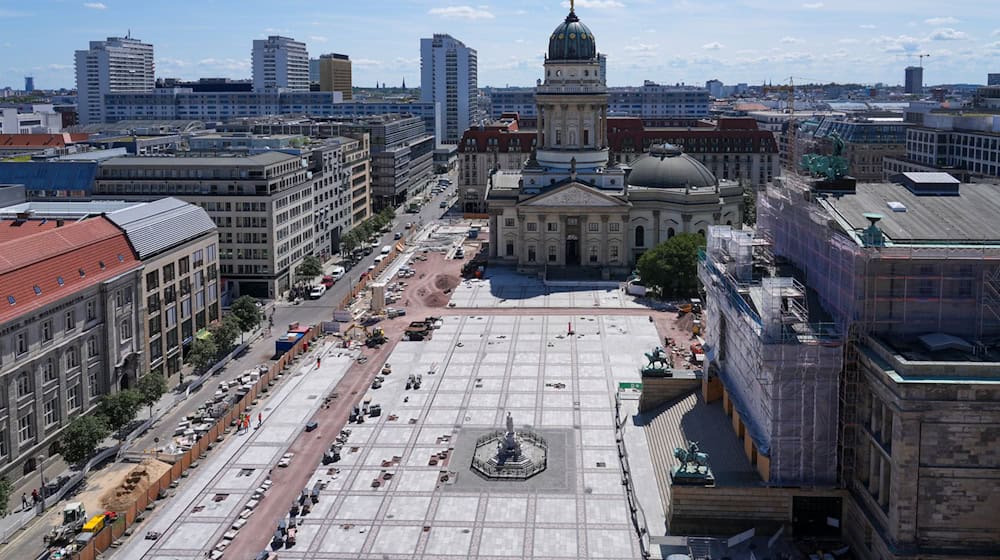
272,316,659,560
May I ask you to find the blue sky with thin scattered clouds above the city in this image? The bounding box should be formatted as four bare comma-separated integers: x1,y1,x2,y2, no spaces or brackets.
0,0,1000,89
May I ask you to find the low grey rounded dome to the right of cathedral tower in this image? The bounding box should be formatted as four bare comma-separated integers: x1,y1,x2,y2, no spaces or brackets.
628,144,718,189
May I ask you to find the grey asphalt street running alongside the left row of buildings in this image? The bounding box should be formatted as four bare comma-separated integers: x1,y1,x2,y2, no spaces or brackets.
0,172,460,560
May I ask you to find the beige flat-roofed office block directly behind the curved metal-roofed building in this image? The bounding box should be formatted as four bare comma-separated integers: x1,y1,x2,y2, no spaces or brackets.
93,152,314,299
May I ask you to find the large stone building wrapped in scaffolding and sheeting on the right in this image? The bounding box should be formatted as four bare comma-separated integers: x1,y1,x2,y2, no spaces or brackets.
699,173,1000,559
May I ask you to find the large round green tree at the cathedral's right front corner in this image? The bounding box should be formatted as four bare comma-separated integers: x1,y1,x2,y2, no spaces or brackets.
636,233,705,298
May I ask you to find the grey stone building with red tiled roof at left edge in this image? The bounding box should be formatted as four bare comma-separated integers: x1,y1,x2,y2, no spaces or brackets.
0,215,143,480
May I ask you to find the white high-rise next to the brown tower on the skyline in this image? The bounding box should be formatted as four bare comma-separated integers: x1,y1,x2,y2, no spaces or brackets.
253,35,309,91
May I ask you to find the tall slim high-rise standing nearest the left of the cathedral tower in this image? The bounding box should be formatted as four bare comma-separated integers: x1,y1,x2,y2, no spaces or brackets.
420,34,479,144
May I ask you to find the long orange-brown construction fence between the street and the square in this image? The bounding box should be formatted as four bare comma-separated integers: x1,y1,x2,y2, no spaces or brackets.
72,327,318,560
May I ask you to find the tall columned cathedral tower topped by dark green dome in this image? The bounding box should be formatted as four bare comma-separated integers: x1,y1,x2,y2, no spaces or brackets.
535,2,608,174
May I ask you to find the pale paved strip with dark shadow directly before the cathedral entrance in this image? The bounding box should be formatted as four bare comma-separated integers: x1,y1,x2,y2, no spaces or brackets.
451,267,648,310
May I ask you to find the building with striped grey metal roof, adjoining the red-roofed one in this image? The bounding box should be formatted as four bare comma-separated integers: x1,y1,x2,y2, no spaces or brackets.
0,198,222,384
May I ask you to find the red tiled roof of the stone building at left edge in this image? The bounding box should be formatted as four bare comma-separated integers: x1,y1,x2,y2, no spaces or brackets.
0,217,141,323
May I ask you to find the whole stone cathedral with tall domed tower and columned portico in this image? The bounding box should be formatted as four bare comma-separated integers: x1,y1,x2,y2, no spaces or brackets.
486,2,743,276
